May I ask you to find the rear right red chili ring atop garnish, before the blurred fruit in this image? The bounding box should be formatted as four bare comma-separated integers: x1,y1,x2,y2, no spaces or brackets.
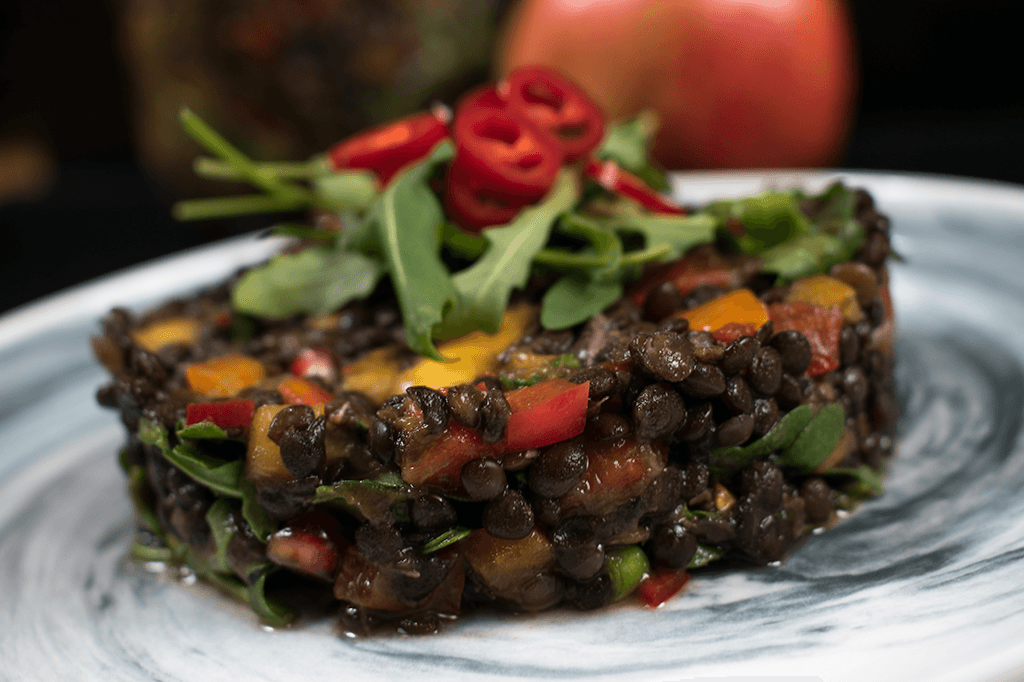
500,69,604,162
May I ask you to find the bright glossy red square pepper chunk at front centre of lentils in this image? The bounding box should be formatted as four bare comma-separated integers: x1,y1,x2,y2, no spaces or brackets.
505,379,590,453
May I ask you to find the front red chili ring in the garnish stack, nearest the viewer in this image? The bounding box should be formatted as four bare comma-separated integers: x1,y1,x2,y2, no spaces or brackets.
452,96,562,206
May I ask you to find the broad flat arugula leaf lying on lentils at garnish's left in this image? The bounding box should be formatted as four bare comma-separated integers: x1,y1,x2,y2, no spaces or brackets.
231,246,383,319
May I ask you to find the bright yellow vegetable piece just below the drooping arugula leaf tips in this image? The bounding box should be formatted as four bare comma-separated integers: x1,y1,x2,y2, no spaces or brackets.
393,305,536,393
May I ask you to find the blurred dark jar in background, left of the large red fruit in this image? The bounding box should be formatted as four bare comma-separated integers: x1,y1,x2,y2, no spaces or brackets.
118,0,508,197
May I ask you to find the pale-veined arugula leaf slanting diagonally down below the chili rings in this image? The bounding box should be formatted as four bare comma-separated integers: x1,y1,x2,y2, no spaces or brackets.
434,169,580,338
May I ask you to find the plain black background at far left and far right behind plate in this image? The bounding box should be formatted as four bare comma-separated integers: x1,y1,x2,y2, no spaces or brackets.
0,0,1024,312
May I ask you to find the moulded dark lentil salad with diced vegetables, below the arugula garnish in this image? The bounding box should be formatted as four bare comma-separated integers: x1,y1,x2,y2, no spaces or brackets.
93,184,897,632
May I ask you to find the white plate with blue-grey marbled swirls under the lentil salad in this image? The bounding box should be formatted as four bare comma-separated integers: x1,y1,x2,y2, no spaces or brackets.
0,172,1024,682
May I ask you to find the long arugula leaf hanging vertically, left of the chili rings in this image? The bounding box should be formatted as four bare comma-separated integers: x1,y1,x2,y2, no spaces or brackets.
367,142,458,361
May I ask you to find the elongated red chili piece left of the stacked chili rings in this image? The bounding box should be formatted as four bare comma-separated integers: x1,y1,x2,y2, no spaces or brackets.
328,112,449,184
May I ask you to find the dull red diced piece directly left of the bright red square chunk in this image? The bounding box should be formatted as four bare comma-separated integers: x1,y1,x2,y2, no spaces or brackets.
399,420,505,493
